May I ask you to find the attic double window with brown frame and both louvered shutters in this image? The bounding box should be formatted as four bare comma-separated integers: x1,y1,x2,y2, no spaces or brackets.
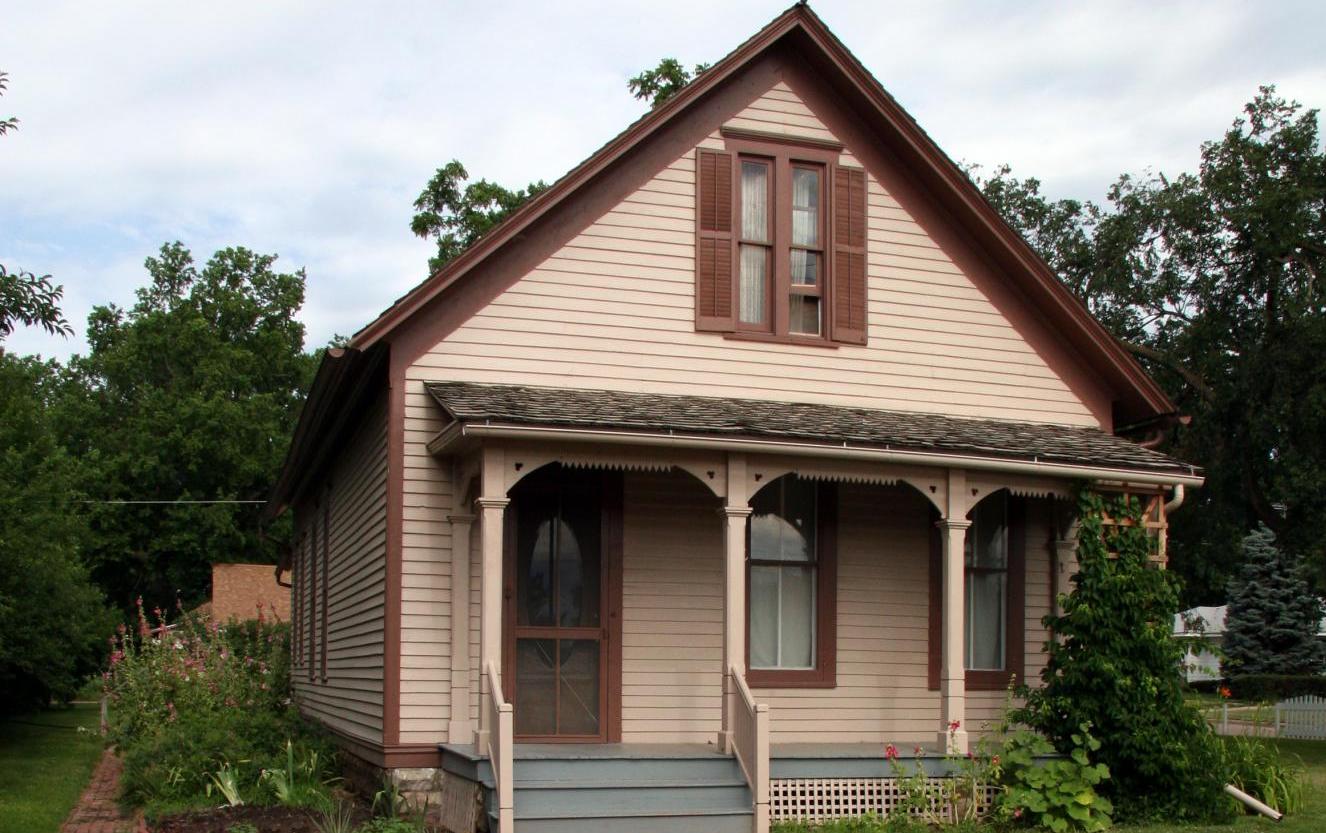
695,138,866,344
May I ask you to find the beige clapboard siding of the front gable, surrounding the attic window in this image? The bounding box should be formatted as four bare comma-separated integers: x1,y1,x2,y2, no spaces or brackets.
407,84,1098,429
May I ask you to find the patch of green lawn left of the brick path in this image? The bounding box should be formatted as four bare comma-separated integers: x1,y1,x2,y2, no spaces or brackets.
0,704,102,833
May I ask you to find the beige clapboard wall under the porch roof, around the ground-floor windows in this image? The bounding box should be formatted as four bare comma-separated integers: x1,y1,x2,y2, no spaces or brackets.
622,474,1049,743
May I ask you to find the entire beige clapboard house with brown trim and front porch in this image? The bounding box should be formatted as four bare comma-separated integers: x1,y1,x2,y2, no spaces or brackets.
269,4,1201,833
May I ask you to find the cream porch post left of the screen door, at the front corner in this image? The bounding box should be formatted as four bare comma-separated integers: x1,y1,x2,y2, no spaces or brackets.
475,448,511,753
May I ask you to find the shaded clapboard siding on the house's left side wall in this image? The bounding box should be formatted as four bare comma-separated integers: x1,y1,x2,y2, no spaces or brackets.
292,395,387,743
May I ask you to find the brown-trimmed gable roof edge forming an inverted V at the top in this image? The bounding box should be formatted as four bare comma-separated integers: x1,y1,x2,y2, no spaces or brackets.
349,3,1175,426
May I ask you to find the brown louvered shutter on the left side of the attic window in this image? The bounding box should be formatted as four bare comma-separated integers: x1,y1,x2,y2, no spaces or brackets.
695,149,733,332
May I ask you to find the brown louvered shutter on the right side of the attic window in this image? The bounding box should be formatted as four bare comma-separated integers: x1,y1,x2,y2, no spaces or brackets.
829,166,866,344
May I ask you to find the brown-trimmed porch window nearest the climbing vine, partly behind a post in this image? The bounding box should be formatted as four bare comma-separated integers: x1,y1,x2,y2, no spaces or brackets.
930,491,1026,691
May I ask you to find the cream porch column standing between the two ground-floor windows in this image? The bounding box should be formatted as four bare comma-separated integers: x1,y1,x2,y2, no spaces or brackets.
936,517,972,755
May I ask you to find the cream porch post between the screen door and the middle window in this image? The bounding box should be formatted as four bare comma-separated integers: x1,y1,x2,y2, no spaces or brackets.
719,455,751,752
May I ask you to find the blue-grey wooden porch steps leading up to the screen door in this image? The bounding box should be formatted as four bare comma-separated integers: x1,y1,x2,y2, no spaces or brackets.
444,744,753,833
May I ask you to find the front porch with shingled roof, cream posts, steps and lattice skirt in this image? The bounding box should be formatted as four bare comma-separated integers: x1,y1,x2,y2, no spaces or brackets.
428,385,1198,833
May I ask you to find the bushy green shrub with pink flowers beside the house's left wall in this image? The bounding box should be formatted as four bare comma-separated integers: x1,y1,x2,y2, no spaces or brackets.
106,605,335,809
